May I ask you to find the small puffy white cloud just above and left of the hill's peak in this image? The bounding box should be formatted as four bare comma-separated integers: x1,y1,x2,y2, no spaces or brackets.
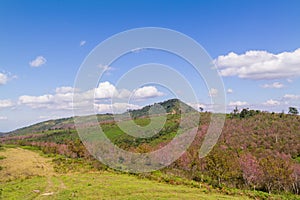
132,86,164,99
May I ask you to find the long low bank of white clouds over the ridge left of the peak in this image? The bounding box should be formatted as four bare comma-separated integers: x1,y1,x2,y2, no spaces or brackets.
18,81,163,112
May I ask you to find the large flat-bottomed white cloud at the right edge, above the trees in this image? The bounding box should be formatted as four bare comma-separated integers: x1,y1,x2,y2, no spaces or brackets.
214,48,300,79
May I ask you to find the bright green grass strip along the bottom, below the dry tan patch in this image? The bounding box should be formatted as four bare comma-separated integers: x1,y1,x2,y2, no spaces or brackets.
2,172,251,199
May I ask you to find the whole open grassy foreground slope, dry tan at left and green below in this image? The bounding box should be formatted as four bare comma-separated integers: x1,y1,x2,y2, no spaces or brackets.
0,148,247,199
